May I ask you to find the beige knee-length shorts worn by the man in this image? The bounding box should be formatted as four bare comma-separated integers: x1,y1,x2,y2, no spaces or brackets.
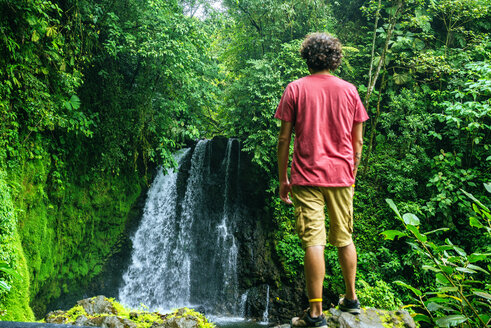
292,185,353,249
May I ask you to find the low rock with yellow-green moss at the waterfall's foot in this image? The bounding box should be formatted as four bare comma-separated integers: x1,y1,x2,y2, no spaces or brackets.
44,296,215,328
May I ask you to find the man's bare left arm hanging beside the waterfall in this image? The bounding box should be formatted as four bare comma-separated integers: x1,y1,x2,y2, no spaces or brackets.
277,121,293,204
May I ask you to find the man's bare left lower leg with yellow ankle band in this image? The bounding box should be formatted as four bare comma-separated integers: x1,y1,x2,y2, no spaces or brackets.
304,246,326,318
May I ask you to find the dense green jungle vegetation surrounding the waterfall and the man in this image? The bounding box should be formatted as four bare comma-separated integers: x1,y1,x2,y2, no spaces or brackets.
0,0,491,327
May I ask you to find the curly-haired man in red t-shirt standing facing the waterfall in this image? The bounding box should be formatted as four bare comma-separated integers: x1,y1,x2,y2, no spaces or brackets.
275,33,368,328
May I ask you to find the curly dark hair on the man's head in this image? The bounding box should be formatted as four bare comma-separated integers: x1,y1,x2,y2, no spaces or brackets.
300,33,343,72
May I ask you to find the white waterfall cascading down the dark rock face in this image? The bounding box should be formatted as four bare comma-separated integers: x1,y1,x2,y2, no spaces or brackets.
119,139,242,316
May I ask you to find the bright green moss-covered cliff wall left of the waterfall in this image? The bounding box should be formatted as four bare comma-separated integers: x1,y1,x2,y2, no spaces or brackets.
0,152,142,320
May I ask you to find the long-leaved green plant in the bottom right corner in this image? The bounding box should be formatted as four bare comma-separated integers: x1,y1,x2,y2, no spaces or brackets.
383,192,491,327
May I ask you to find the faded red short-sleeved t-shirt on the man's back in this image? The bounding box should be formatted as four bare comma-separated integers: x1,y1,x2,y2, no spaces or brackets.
275,74,368,187
